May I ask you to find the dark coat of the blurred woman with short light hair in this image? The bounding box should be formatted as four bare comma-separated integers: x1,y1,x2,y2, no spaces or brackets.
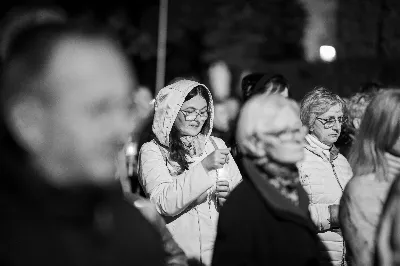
212,158,321,266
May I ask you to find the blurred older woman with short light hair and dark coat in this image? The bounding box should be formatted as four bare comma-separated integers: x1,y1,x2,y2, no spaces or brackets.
212,94,322,266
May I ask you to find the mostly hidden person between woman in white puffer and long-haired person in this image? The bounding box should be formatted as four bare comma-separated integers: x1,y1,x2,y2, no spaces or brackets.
336,93,375,158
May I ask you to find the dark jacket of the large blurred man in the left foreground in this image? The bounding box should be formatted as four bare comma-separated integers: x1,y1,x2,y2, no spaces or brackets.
0,131,165,266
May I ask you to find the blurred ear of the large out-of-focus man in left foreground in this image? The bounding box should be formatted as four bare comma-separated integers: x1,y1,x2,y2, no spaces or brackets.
9,98,45,151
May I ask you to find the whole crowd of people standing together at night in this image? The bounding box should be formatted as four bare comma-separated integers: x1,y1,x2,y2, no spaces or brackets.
0,5,400,266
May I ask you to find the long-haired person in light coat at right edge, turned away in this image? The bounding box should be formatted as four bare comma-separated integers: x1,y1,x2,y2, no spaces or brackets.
339,90,400,266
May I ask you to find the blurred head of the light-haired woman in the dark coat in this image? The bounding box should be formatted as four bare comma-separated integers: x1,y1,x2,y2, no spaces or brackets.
236,94,307,164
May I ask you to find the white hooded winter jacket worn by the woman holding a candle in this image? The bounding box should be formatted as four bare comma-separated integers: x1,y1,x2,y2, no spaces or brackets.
139,81,242,266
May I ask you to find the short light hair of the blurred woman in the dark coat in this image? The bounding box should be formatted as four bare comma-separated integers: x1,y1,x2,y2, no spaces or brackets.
236,94,300,157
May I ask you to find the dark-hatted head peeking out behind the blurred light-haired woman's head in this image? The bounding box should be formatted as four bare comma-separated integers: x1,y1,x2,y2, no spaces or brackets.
242,73,290,101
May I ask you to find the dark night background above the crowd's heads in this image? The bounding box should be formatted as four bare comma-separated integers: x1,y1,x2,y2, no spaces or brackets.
0,0,400,99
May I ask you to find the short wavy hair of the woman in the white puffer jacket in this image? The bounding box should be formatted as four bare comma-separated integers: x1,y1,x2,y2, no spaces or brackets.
300,87,345,129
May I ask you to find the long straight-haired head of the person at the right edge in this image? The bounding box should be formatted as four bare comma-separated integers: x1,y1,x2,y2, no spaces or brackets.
349,89,400,180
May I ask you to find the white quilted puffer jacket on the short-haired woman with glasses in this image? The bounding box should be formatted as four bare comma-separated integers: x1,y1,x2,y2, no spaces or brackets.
299,134,352,265
